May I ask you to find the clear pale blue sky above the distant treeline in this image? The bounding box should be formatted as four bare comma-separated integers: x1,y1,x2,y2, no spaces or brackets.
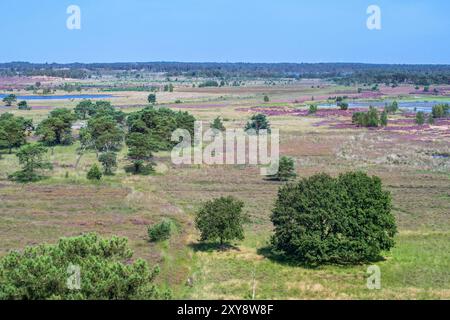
0,0,450,64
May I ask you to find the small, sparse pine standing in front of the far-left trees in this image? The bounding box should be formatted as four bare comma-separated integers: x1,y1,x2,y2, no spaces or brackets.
9,143,53,182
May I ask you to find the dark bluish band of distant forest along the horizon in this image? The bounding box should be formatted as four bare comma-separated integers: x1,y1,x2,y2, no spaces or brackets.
0,62,450,85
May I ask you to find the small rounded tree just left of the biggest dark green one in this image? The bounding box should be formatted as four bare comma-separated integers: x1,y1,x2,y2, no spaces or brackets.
195,197,247,245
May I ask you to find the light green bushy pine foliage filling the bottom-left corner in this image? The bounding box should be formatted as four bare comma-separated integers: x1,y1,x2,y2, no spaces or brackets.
0,234,170,300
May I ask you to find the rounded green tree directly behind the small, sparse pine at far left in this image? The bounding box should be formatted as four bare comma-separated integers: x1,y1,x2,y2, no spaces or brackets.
36,108,76,146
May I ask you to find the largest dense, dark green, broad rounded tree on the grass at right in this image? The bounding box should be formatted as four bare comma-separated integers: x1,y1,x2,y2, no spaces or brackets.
271,172,397,265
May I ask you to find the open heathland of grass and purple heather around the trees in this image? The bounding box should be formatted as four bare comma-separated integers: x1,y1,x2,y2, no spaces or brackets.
0,78,450,299
